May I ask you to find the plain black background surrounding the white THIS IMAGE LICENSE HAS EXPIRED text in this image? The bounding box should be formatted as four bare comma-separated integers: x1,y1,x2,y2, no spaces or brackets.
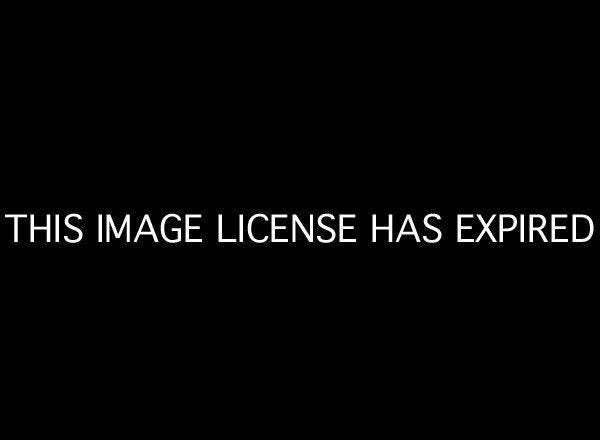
1,5,598,433
